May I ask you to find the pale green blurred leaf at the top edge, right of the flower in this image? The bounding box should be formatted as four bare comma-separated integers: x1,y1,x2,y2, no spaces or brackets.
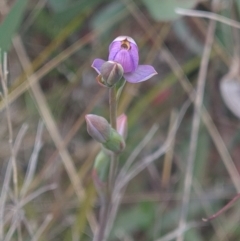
142,0,197,21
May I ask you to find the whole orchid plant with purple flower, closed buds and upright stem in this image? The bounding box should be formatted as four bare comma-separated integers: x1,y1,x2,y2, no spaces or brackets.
85,36,157,241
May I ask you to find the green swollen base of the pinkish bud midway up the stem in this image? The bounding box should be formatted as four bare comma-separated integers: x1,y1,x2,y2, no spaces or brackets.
103,128,125,153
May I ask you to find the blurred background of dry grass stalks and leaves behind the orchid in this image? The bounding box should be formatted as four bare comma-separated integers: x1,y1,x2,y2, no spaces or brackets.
0,0,240,241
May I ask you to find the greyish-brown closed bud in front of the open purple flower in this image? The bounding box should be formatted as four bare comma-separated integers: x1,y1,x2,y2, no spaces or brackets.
100,61,123,87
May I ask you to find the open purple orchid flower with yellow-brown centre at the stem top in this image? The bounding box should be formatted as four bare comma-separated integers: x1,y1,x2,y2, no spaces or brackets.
92,36,157,83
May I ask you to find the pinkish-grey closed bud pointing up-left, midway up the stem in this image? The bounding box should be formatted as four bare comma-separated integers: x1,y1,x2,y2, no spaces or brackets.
85,114,111,143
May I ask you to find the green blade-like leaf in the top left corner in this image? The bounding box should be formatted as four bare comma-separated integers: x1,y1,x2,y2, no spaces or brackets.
0,0,28,52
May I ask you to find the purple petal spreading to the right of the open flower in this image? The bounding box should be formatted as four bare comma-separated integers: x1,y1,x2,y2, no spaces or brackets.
123,65,157,83
